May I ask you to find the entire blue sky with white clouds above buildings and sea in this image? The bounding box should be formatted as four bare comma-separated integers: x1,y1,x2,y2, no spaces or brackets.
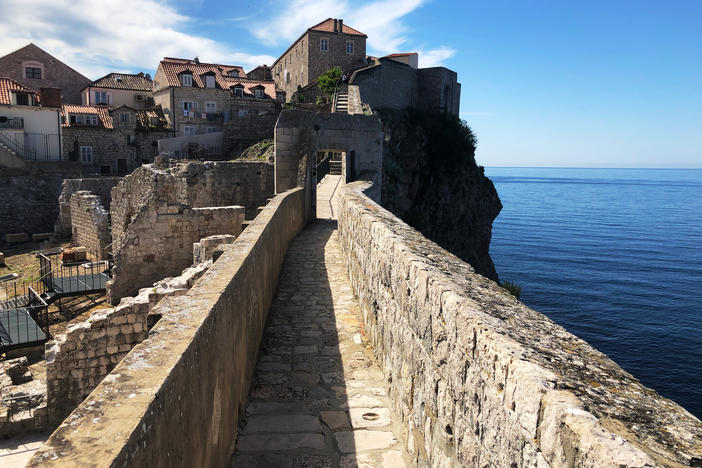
0,0,702,168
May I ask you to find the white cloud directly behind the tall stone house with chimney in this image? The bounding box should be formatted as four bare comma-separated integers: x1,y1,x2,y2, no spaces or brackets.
250,0,427,55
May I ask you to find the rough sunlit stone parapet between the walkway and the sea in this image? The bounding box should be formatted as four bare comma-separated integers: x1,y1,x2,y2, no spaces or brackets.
339,182,702,467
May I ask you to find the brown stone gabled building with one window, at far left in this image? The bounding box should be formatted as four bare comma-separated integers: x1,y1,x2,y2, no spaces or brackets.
0,44,90,104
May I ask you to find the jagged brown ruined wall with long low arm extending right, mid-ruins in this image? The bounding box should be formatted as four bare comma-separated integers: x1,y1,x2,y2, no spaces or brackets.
107,200,244,304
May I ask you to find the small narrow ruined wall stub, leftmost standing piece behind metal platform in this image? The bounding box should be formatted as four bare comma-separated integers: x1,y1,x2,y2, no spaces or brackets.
70,191,112,260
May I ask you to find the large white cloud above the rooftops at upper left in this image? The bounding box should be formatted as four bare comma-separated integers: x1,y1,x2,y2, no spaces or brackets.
0,0,275,79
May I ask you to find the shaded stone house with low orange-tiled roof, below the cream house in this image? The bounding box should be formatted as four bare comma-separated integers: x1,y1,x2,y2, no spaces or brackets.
62,105,170,175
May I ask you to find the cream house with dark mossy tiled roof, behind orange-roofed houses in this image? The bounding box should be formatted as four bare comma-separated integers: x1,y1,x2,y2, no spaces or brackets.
82,73,154,109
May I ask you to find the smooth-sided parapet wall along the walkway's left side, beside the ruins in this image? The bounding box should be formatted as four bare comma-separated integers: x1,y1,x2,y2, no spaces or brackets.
28,188,307,468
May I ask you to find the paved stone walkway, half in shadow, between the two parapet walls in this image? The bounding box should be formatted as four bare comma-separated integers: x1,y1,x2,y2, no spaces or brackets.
232,220,409,468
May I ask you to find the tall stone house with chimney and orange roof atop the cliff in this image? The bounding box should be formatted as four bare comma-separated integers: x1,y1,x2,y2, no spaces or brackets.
273,18,368,97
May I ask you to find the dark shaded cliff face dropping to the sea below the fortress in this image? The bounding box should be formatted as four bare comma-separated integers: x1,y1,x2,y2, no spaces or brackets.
379,109,502,281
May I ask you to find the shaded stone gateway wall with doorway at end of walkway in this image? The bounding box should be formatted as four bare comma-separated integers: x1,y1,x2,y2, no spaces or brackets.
275,110,383,193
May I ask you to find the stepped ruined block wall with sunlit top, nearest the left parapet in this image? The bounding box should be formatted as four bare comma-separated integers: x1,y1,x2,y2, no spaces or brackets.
45,264,209,427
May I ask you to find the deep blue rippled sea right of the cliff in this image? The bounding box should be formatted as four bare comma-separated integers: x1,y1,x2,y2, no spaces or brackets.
485,168,702,418
